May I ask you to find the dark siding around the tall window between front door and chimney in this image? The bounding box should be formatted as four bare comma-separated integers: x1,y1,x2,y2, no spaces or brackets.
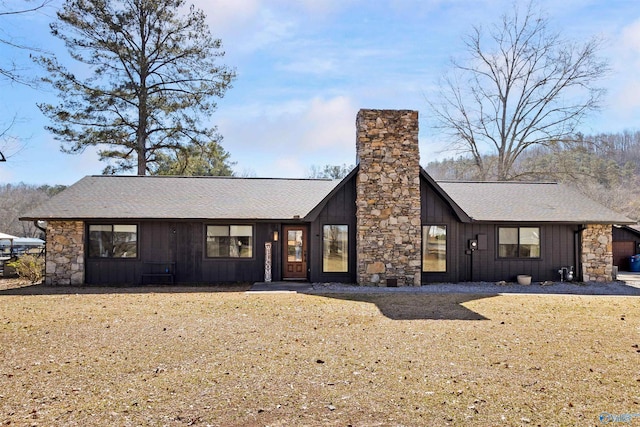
309,175,356,283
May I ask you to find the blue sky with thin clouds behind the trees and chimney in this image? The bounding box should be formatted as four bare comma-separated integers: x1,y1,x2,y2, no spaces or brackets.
0,0,640,185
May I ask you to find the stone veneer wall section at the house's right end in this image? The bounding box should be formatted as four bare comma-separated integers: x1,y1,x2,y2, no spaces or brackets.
582,224,613,282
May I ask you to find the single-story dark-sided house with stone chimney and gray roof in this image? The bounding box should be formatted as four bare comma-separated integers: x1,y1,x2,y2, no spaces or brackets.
21,110,633,286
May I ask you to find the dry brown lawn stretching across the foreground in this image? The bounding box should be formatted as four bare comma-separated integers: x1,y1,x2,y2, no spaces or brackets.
0,280,640,426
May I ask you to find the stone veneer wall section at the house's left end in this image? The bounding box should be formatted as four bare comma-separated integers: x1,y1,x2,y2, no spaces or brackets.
45,221,84,285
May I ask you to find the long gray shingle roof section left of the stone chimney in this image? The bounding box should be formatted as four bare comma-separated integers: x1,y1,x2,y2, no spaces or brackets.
23,175,339,220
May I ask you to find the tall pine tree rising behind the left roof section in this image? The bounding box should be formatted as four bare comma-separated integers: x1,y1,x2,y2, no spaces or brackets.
37,0,235,175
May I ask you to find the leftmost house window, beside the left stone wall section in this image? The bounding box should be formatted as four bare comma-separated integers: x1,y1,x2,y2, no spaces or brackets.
89,224,138,258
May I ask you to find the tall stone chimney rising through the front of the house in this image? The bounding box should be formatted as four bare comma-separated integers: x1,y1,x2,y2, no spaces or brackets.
356,110,422,286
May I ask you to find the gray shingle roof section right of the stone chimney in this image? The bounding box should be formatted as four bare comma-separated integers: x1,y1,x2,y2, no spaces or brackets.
437,181,634,224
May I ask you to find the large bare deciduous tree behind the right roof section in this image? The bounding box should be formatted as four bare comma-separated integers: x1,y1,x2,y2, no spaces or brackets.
430,0,608,181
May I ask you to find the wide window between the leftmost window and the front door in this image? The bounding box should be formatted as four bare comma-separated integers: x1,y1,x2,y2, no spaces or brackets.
207,225,253,258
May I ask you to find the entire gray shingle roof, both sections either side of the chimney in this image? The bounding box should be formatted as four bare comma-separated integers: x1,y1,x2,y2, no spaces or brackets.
22,175,634,224
